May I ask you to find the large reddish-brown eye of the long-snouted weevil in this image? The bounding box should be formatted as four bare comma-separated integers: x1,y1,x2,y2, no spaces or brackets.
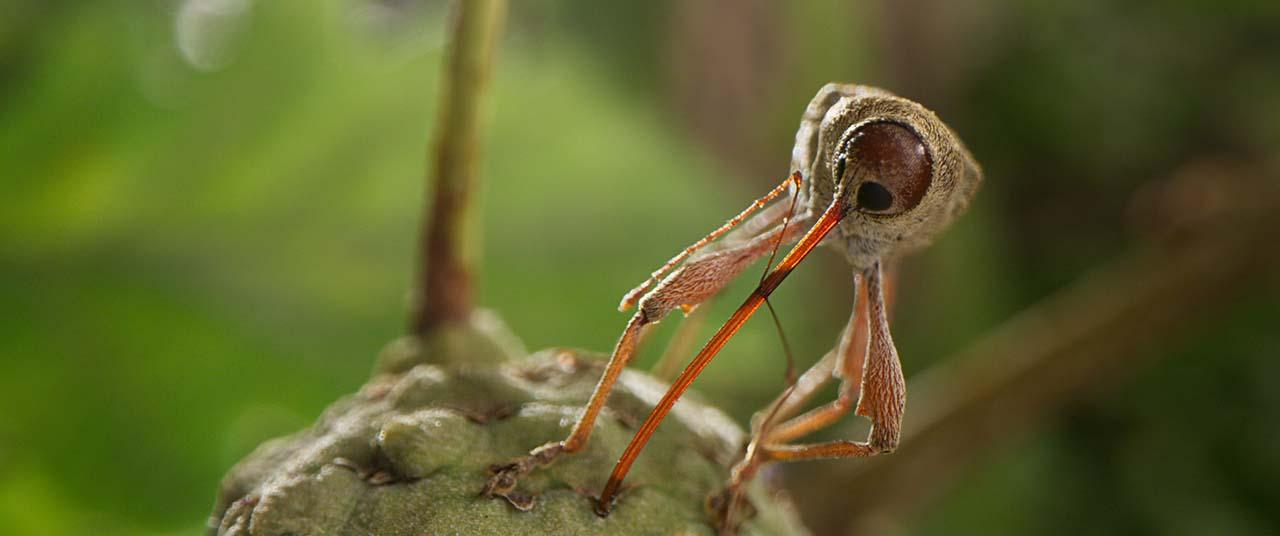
845,122,933,215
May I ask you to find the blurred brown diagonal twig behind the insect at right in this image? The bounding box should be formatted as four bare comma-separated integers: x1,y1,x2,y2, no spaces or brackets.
790,166,1280,533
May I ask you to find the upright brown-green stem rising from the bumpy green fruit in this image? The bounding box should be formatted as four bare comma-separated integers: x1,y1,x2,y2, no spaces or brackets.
410,0,506,335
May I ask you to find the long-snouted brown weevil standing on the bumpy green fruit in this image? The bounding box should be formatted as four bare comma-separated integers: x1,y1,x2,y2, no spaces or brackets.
484,83,982,524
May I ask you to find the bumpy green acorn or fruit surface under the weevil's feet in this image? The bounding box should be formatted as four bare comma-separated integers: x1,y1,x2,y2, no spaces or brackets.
209,313,805,535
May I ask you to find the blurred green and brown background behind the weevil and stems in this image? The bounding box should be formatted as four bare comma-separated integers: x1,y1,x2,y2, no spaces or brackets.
0,0,1280,535
